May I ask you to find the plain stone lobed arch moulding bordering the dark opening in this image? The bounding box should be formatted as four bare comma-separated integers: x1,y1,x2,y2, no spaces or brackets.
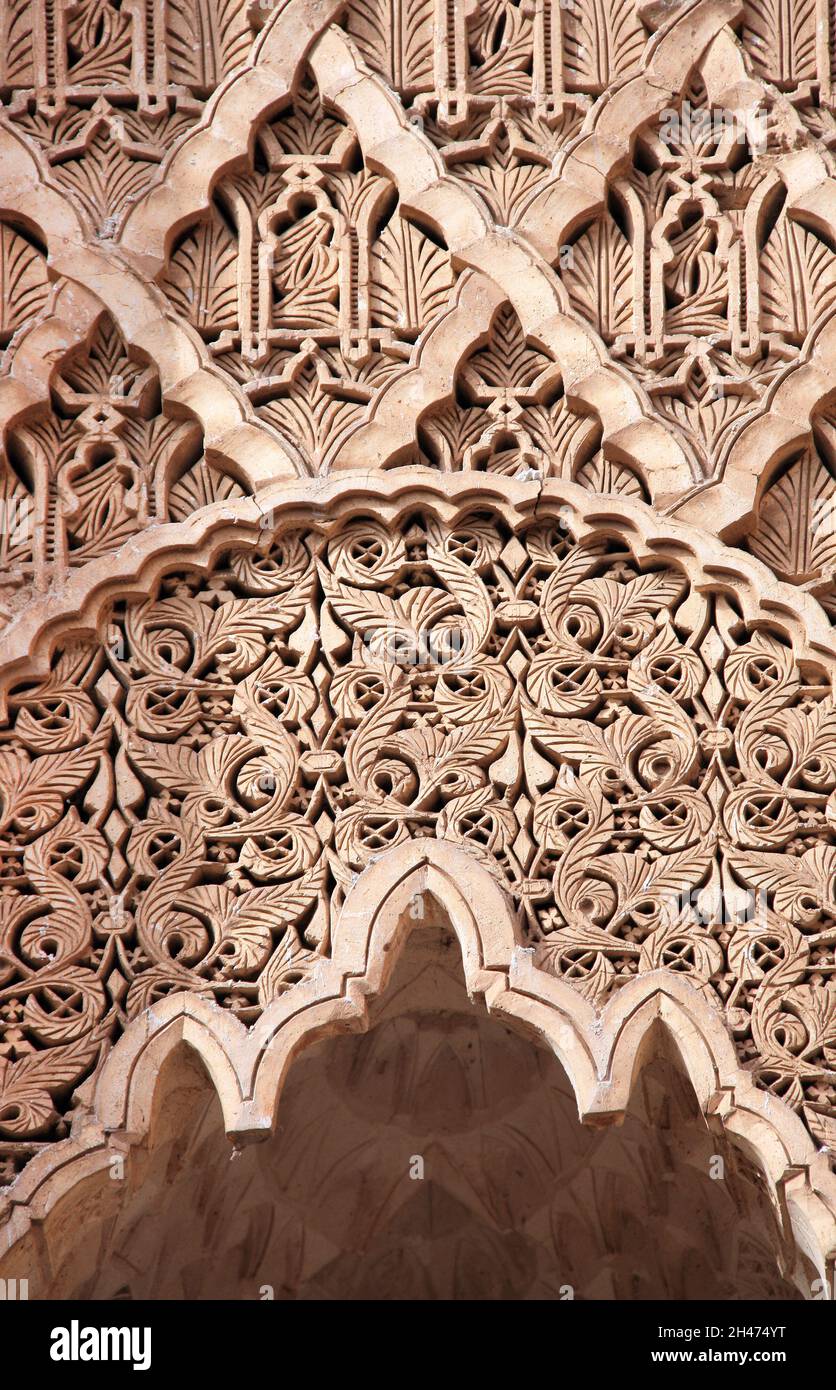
0,844,836,1297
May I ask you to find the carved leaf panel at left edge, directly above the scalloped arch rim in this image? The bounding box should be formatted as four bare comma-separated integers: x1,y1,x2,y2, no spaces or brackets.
0,313,215,616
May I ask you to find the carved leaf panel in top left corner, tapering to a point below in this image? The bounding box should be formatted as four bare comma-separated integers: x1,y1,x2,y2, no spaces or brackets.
0,0,259,235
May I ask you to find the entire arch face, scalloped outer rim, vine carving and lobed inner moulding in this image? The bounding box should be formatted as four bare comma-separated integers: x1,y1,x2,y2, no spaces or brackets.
3,475,836,1289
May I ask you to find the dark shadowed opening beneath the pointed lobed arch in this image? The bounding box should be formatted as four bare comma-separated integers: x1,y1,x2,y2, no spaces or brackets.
0,895,800,1300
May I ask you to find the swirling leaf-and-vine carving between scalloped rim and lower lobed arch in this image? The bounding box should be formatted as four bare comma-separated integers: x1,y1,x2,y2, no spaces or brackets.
0,489,836,1162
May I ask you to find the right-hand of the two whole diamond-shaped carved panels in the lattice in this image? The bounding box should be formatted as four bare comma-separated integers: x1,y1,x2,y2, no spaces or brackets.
562,69,836,480
